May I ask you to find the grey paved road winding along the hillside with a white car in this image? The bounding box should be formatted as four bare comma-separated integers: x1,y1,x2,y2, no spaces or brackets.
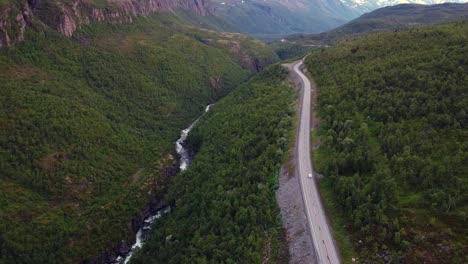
292,60,340,264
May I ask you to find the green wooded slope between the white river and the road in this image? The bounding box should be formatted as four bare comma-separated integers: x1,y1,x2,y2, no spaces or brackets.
132,65,294,263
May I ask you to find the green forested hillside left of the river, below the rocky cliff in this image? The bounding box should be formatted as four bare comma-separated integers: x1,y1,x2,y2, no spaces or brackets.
0,13,278,264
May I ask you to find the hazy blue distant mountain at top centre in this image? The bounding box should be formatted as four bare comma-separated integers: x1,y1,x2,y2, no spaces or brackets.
208,0,357,38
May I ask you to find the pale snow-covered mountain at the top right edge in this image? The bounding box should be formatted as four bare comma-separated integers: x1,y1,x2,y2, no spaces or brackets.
341,0,468,14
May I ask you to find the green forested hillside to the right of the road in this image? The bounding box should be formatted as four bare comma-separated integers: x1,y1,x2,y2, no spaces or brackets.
306,22,468,263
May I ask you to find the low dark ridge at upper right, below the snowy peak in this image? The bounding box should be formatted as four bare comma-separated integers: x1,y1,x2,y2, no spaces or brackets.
287,3,468,45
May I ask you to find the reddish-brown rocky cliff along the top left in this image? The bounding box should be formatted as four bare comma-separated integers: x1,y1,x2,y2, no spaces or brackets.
0,0,208,47
